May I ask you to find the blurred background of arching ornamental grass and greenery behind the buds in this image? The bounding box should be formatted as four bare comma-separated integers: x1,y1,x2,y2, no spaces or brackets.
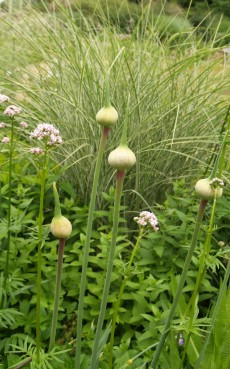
0,0,230,206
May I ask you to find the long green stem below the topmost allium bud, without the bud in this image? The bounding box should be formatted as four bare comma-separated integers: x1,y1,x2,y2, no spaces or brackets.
75,127,109,369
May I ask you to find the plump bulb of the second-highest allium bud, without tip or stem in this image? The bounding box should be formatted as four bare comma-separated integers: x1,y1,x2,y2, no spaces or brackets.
108,145,136,170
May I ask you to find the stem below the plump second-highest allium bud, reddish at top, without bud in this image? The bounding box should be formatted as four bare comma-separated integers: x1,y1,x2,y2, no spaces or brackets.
90,171,125,369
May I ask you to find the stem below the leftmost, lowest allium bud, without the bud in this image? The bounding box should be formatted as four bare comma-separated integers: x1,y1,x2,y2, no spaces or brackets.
49,238,66,351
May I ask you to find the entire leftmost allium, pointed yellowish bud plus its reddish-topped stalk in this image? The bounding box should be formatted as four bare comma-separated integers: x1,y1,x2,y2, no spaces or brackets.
49,182,72,351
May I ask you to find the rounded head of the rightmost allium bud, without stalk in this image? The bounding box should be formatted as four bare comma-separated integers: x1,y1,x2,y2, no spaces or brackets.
195,178,223,200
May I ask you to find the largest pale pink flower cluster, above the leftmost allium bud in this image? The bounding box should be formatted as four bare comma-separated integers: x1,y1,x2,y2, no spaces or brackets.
30,123,62,146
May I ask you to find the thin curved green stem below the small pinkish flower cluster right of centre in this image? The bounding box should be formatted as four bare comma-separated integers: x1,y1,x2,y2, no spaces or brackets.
108,228,143,369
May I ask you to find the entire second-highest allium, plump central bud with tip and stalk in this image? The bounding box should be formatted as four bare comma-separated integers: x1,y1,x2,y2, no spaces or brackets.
90,95,136,369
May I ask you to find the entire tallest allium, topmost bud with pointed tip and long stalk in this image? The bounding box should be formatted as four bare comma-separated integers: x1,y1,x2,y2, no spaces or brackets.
75,79,118,369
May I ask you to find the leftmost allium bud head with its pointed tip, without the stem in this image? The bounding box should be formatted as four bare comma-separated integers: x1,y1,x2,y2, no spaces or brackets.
50,182,72,238
